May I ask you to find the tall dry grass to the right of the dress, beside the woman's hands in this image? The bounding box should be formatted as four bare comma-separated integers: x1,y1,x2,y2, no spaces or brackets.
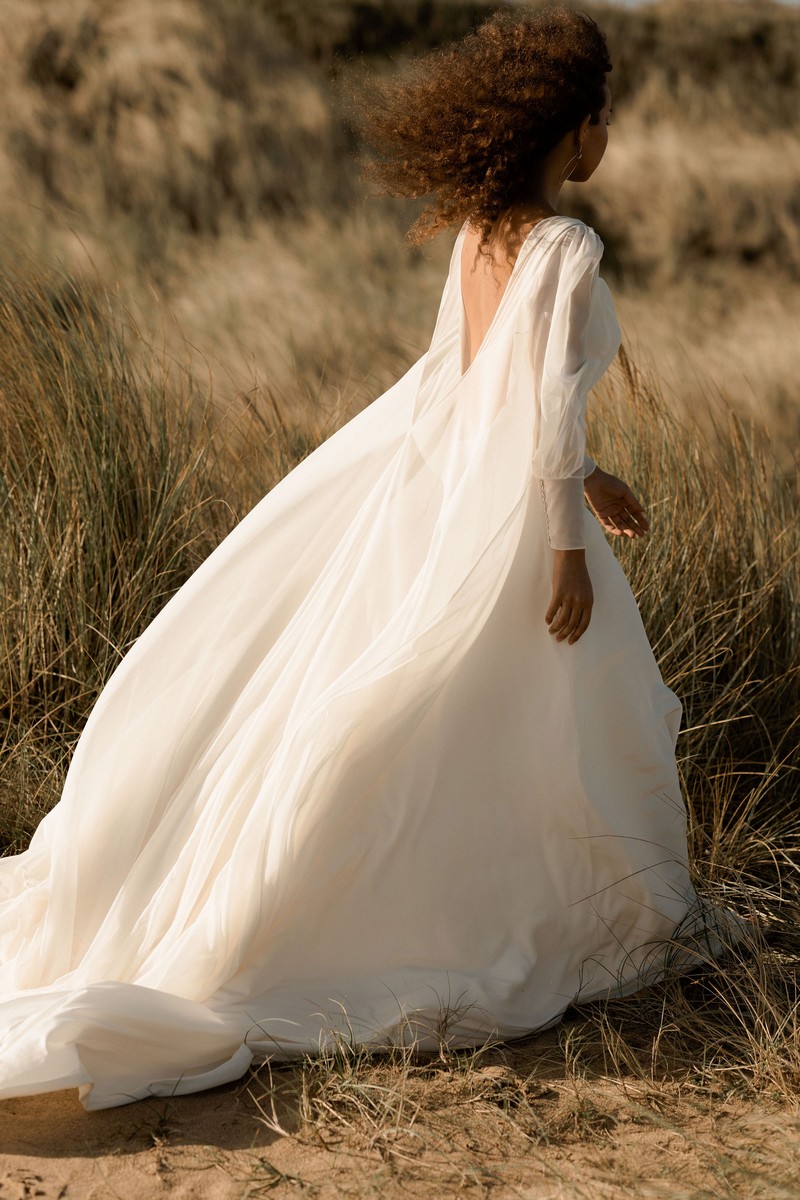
593,349,800,930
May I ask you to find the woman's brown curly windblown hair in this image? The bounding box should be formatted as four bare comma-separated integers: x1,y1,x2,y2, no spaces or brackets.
351,6,612,245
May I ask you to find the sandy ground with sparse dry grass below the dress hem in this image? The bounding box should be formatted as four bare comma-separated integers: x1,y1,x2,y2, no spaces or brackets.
0,1027,800,1200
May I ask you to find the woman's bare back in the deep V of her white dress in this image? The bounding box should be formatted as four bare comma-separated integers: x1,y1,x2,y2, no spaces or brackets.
459,214,561,374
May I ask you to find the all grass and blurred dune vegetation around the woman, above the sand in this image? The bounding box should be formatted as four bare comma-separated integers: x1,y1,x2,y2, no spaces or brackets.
0,0,800,1147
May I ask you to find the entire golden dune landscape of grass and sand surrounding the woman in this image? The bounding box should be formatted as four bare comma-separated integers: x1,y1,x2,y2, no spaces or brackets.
0,0,800,1200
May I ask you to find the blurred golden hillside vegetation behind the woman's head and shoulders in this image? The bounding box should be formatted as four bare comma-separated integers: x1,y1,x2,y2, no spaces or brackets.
0,0,800,432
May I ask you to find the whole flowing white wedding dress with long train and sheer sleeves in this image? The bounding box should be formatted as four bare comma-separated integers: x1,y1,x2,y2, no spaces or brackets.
0,215,738,1109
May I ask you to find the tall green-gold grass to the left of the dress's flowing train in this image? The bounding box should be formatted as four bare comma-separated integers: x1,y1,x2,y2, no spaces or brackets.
0,260,330,848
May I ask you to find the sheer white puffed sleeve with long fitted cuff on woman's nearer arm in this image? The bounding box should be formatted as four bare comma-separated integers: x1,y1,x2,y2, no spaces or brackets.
533,223,603,550
